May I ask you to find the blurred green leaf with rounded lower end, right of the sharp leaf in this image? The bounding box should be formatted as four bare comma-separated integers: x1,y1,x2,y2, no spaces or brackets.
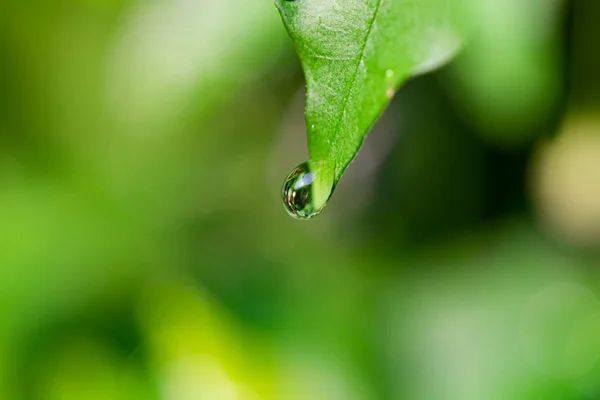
446,0,564,145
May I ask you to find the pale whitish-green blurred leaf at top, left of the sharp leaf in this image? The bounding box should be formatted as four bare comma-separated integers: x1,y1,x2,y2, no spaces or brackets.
108,0,285,135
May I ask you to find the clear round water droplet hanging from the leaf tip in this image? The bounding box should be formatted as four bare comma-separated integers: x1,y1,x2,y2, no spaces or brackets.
282,161,333,219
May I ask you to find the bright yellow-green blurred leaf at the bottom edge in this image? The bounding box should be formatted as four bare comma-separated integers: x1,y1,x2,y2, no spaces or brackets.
139,279,280,400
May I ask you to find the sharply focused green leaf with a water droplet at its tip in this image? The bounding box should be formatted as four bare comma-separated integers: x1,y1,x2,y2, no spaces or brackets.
275,0,471,218
